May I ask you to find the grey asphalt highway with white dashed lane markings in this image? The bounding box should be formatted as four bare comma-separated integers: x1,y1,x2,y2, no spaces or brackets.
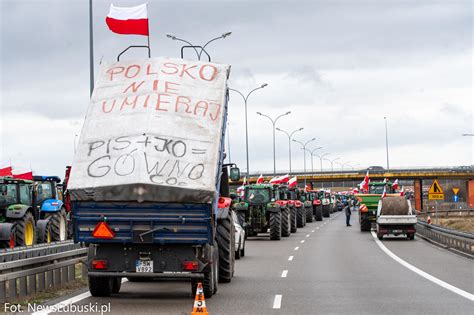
42,212,474,315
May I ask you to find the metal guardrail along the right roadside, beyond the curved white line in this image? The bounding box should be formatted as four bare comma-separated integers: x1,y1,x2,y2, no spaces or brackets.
416,220,474,259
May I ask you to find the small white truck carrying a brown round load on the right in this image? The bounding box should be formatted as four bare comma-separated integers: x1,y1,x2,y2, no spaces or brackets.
376,196,417,240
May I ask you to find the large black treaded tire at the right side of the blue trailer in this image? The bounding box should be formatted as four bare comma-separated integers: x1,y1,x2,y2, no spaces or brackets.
217,214,235,282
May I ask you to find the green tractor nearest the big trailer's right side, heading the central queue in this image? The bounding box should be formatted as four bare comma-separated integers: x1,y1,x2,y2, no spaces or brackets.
235,184,290,240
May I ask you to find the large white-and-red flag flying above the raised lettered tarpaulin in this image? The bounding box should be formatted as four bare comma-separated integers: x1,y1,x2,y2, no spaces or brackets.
105,3,149,36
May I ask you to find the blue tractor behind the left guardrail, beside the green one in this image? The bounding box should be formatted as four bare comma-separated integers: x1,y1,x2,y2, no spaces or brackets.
33,176,68,242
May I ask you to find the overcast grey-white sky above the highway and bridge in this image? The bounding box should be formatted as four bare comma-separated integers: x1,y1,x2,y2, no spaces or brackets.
0,0,474,177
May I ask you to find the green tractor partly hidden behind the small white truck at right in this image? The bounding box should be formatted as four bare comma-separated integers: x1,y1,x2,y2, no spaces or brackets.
354,182,398,231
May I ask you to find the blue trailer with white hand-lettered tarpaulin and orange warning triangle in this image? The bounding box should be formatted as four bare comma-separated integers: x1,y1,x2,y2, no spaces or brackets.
67,57,240,298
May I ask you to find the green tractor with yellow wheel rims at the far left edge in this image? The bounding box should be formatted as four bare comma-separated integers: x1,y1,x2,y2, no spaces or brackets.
0,177,51,248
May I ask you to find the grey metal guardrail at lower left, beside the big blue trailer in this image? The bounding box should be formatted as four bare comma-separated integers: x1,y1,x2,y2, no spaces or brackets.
0,241,87,303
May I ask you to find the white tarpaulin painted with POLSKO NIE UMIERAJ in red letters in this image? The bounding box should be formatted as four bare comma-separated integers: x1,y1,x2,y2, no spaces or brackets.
68,58,230,203
